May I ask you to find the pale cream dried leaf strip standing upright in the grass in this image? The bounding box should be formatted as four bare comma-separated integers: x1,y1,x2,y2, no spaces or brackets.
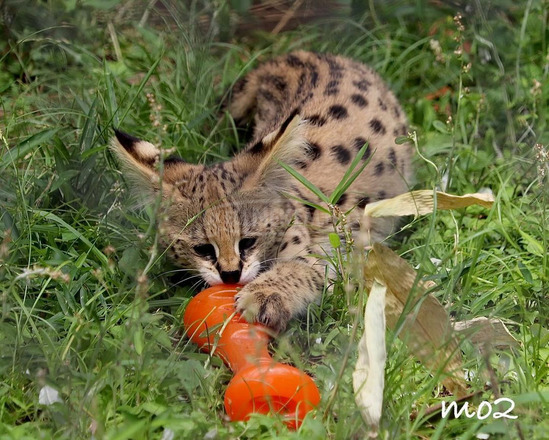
353,281,387,429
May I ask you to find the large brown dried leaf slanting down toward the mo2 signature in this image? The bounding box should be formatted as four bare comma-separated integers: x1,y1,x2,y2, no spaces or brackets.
364,243,467,396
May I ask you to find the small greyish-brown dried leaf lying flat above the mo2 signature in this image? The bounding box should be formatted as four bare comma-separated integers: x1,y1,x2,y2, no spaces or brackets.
453,317,519,349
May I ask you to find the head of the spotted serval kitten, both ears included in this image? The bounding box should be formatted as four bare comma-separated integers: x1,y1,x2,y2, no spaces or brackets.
112,116,306,285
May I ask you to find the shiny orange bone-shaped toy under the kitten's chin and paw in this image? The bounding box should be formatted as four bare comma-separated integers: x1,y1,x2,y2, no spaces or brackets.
183,284,320,429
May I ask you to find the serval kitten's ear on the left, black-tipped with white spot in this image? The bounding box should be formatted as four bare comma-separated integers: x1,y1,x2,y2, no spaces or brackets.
111,130,192,195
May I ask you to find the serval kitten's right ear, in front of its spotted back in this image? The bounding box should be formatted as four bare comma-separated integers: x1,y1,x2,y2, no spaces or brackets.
243,112,308,191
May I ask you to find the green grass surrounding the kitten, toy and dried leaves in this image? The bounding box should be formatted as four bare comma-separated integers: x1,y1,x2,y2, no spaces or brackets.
0,0,549,439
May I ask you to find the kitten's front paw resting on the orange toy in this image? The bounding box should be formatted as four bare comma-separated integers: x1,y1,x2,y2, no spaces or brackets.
235,282,291,333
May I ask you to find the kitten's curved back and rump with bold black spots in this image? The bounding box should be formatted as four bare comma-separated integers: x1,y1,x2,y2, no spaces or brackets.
228,51,412,217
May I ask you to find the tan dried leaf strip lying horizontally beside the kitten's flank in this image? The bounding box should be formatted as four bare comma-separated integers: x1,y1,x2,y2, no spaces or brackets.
364,189,494,217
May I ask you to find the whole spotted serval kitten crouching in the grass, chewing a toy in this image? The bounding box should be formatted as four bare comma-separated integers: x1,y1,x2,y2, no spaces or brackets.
113,52,412,331
